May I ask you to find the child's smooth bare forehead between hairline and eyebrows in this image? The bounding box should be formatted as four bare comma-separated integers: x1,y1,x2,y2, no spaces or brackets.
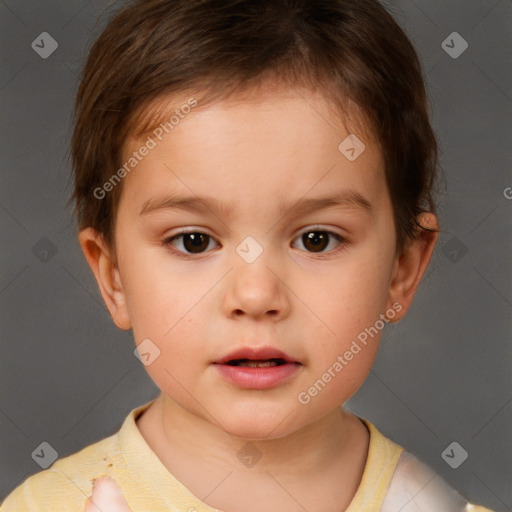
119,89,386,214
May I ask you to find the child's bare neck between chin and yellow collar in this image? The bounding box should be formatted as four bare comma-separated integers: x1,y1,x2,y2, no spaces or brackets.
137,394,369,512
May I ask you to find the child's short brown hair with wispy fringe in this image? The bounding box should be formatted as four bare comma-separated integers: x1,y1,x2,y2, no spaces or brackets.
70,0,438,252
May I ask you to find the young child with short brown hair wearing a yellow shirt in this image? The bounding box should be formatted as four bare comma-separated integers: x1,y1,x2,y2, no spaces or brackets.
1,0,496,512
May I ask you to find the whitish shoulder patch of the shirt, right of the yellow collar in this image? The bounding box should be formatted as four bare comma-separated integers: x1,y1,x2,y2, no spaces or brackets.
381,451,496,512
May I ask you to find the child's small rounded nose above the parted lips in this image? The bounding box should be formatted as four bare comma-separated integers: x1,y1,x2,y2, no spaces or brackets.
222,251,290,320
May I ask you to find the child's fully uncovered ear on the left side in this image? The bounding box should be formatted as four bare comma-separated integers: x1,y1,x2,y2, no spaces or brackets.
78,228,131,330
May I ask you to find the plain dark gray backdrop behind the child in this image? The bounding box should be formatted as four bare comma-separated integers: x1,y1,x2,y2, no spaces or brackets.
0,0,512,511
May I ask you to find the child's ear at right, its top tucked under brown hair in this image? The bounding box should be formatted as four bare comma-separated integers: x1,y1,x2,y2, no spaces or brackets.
386,213,439,322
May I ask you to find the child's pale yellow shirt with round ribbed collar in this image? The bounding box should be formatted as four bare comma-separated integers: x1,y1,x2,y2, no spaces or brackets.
0,402,496,512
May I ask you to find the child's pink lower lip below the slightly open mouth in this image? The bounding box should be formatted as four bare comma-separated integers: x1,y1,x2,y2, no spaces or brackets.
215,363,301,389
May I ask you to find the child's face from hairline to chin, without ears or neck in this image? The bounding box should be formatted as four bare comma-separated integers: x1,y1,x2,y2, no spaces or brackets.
84,86,428,439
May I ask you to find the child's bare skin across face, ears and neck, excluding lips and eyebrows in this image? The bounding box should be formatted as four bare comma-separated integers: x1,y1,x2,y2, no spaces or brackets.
79,88,438,512
